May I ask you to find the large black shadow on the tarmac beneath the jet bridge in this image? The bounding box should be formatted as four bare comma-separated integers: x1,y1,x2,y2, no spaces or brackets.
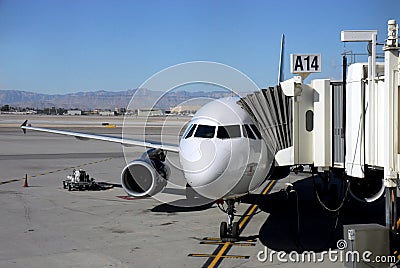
242,178,392,252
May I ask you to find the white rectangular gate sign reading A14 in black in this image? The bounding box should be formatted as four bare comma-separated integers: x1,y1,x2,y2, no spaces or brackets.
290,54,321,74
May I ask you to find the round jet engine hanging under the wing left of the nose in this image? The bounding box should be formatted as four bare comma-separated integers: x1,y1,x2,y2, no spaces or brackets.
121,149,170,197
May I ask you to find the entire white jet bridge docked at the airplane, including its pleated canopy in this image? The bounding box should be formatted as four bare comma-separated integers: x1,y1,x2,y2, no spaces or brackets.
238,20,400,237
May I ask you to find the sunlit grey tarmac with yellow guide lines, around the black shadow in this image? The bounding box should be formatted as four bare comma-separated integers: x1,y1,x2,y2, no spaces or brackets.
0,115,390,268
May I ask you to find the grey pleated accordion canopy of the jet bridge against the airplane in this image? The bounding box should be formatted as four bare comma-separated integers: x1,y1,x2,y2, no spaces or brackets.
238,86,293,154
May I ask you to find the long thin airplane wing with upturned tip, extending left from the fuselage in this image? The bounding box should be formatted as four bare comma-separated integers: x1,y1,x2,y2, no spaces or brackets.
21,120,179,153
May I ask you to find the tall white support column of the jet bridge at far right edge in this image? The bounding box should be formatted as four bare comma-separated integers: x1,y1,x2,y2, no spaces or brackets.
383,20,399,234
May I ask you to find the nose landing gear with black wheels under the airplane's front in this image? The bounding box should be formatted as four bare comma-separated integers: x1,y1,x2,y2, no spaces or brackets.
219,199,239,242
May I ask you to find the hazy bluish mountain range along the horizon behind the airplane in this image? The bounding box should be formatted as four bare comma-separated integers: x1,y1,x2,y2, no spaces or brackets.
0,89,238,110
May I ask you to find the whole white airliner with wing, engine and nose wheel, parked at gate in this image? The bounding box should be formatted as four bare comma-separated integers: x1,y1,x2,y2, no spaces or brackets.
21,97,282,239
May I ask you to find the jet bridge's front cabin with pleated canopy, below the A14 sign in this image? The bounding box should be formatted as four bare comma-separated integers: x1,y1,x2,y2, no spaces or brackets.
239,76,332,168
